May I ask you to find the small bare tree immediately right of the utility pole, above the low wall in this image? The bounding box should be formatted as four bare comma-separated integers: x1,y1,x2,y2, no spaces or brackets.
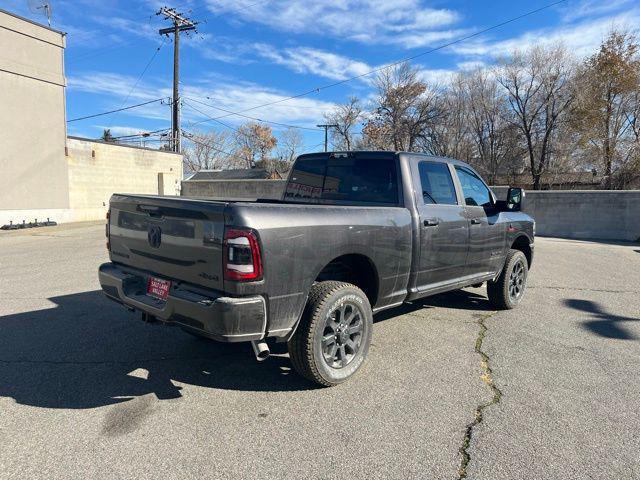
183,130,237,172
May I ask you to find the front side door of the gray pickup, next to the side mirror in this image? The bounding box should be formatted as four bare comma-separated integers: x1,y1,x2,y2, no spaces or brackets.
455,165,506,276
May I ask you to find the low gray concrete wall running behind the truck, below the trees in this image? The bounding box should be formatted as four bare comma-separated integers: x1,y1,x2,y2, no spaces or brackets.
182,180,640,241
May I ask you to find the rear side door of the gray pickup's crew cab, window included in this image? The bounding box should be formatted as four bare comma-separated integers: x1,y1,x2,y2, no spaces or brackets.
412,160,469,291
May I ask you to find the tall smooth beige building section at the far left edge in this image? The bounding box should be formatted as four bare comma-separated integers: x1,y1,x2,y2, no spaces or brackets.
0,10,69,211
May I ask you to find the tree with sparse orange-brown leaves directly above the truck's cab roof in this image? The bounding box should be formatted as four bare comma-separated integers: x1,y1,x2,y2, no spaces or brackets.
364,63,442,151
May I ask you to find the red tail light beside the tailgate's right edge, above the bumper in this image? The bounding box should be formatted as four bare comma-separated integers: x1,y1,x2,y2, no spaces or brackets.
224,228,262,282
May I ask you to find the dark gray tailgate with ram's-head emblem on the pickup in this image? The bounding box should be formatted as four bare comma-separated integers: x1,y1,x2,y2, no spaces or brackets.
109,194,227,290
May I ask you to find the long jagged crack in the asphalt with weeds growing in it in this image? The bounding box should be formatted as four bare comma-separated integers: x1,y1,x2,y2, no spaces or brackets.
456,311,502,480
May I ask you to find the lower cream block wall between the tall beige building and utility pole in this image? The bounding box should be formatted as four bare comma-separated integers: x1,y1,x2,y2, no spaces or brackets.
67,137,182,221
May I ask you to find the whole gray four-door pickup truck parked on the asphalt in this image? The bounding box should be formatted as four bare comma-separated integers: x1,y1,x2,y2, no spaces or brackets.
99,152,535,386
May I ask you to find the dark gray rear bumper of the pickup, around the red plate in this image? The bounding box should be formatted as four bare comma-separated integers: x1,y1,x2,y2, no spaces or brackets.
98,263,267,342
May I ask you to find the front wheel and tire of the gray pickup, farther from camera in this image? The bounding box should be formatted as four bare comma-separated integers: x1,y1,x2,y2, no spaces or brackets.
487,249,529,310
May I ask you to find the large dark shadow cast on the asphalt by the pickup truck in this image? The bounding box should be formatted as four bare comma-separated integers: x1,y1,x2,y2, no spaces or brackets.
0,291,488,410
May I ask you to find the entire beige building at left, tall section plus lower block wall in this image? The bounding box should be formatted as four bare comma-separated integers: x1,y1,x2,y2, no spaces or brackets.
0,9,182,226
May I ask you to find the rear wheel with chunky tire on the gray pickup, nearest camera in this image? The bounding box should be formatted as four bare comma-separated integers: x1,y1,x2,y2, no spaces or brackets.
288,281,373,387
